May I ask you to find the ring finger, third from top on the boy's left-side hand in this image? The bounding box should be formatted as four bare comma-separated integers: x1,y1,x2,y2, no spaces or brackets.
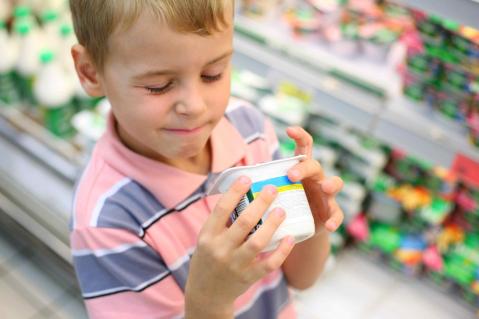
237,207,286,265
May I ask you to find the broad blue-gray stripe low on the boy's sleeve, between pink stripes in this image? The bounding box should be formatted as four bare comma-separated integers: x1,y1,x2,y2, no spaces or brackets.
73,242,169,296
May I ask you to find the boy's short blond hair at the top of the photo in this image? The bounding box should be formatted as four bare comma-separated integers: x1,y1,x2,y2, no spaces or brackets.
70,0,234,69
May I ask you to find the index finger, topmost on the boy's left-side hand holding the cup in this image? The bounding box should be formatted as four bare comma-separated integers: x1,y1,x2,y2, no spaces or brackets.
202,176,251,233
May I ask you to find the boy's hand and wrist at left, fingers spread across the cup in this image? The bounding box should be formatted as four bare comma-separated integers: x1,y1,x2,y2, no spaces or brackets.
185,177,294,318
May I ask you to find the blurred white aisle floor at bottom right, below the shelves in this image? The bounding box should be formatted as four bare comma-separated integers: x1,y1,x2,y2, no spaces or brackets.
297,249,476,319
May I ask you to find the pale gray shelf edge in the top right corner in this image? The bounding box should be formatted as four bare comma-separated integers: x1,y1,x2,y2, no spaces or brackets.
396,0,479,29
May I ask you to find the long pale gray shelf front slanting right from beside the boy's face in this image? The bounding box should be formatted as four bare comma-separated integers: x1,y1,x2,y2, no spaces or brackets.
233,31,479,167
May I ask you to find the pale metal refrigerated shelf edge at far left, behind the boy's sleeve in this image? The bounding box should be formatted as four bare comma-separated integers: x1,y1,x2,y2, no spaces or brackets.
0,107,77,261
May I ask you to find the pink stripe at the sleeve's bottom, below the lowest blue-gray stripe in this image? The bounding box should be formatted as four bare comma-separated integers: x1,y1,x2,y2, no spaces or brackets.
85,276,184,319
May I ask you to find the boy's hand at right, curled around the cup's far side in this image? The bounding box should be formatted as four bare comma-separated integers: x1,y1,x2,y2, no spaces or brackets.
286,126,344,234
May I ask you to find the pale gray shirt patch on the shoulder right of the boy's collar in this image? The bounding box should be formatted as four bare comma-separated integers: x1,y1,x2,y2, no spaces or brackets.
226,106,265,143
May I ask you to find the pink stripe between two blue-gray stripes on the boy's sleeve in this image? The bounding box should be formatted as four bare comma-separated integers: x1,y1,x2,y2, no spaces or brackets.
70,228,140,251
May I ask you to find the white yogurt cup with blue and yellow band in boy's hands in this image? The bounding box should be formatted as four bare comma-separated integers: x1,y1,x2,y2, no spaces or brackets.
208,155,315,251
